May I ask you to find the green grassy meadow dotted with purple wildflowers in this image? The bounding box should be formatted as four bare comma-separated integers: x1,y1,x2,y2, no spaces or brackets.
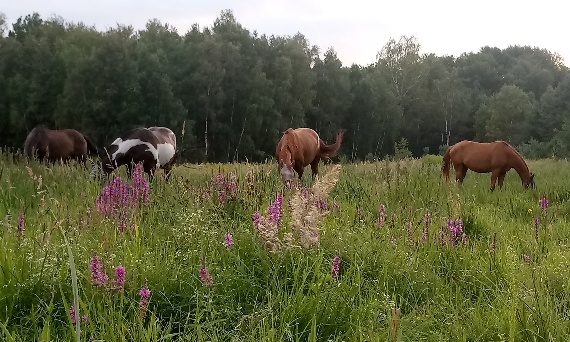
0,153,570,341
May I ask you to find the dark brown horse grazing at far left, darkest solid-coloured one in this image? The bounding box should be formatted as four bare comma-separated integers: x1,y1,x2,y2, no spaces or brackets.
24,125,98,163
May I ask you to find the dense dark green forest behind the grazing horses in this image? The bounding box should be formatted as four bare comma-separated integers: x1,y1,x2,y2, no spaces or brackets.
0,10,570,162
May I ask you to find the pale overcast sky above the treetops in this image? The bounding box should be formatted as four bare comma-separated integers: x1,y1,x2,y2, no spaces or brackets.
0,0,570,66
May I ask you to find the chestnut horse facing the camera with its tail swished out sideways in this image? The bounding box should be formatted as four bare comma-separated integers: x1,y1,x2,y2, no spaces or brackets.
275,128,343,182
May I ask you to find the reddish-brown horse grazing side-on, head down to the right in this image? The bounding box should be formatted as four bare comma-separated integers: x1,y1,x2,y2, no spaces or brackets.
442,140,534,191
